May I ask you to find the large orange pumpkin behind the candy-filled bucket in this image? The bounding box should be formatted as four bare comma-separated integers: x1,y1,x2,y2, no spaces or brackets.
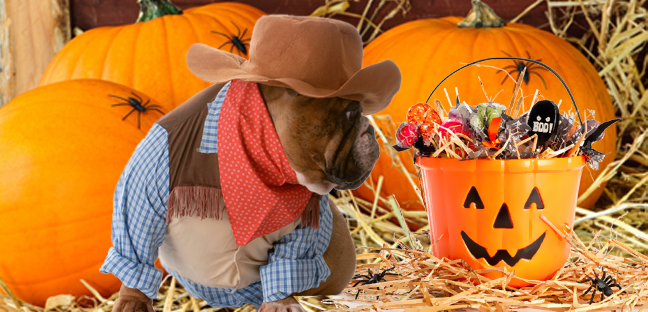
357,1,616,210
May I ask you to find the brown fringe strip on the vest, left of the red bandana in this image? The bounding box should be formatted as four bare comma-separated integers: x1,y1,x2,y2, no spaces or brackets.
167,186,225,224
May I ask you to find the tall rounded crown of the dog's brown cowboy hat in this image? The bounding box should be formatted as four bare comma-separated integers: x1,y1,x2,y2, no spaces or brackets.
243,15,362,90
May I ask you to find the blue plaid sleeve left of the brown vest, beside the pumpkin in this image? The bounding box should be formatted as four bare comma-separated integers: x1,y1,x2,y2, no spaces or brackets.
99,124,169,299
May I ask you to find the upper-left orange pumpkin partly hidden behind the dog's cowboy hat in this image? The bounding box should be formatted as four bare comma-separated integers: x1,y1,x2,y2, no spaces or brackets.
39,0,265,106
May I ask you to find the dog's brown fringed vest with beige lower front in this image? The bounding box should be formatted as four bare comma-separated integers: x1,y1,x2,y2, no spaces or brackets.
158,84,298,289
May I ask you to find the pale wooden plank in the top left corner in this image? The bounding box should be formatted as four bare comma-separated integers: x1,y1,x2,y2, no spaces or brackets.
0,0,70,106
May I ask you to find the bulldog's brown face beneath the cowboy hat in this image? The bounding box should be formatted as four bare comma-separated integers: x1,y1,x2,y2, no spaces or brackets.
259,84,380,194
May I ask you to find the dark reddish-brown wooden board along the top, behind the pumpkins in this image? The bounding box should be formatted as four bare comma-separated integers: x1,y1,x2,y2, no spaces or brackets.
70,0,547,30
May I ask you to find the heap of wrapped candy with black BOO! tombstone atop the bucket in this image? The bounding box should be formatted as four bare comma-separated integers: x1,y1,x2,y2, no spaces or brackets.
393,91,618,168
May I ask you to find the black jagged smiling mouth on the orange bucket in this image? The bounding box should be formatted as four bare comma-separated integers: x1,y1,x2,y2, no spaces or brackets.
461,231,547,267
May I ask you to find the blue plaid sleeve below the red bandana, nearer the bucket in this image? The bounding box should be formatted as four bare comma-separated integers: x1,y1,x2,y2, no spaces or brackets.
261,195,333,302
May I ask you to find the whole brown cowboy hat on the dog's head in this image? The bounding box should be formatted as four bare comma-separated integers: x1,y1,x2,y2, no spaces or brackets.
187,15,401,115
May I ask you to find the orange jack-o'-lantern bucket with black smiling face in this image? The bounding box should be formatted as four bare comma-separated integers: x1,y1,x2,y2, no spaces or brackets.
419,157,585,286
